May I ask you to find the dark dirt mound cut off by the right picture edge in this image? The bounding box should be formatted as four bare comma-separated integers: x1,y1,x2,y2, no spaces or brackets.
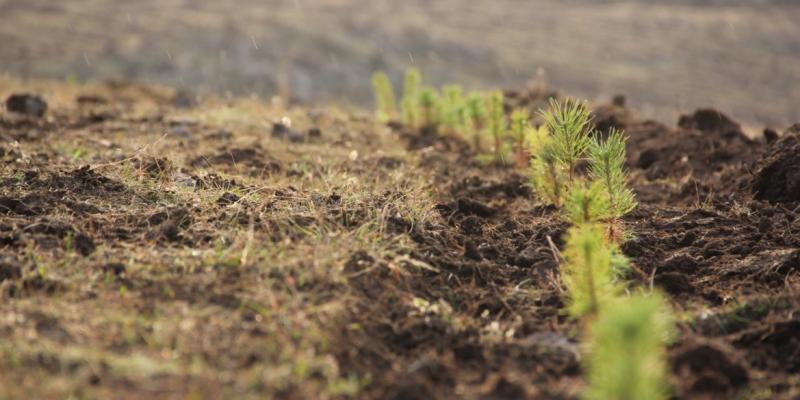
752,124,800,203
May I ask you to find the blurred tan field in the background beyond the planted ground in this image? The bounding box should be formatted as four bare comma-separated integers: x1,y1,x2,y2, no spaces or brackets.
0,0,800,128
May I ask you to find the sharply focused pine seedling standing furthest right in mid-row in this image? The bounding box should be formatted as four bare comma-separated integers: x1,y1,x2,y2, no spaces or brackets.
589,129,636,219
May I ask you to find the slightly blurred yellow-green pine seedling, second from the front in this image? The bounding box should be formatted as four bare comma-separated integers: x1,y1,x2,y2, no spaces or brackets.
561,224,621,319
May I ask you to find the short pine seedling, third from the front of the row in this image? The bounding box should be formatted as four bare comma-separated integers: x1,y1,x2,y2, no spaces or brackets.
563,179,610,225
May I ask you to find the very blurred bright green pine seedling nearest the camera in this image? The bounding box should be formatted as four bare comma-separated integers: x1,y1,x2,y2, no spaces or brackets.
583,293,674,400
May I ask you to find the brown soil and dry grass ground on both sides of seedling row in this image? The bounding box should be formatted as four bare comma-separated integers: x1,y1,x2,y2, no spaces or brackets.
0,76,800,399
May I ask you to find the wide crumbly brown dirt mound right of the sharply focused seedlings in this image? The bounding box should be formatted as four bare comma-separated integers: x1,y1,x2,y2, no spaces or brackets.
625,110,765,204
